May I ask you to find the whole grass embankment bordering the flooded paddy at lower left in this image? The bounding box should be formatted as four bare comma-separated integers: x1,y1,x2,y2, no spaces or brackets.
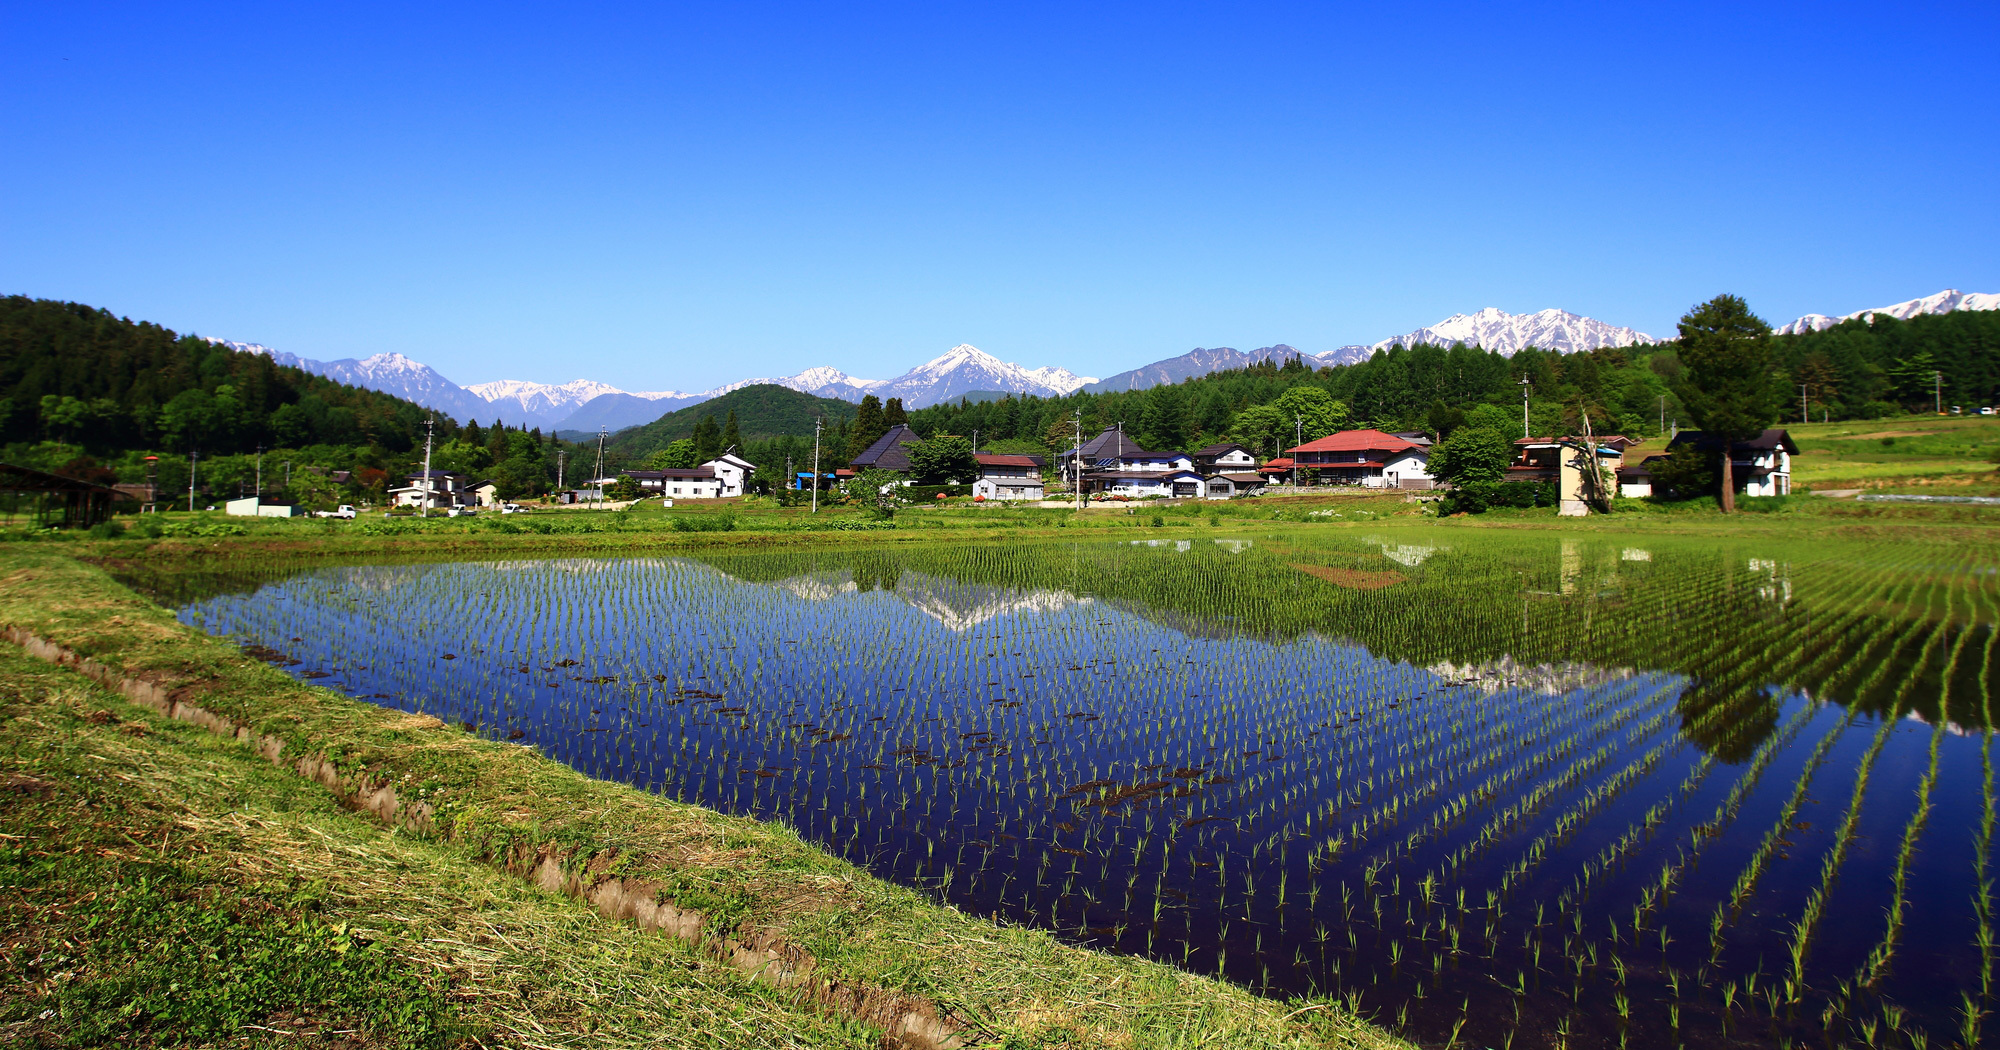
0,544,1402,1048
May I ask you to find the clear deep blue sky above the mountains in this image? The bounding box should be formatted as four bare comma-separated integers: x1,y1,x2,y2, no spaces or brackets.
0,0,2000,390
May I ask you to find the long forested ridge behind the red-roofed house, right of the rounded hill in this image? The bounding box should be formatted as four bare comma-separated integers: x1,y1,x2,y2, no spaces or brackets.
910,310,2000,456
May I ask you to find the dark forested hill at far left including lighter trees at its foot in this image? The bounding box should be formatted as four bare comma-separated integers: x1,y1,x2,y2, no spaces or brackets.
0,296,592,506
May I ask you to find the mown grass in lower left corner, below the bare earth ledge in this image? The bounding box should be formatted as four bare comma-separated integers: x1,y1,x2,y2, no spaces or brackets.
0,646,874,1048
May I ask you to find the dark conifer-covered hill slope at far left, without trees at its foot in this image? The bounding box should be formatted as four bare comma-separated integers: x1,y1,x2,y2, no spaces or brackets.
0,296,458,454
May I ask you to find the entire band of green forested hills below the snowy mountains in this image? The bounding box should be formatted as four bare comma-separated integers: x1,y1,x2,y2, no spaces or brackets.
0,288,2000,506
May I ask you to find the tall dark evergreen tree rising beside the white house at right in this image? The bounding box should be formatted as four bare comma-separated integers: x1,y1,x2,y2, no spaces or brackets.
1674,294,1780,514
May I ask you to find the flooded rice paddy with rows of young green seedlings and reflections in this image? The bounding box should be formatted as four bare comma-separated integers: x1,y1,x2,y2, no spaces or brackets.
134,528,2000,1048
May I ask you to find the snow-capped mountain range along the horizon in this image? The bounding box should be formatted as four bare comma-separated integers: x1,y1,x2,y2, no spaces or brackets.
216,288,2000,432
